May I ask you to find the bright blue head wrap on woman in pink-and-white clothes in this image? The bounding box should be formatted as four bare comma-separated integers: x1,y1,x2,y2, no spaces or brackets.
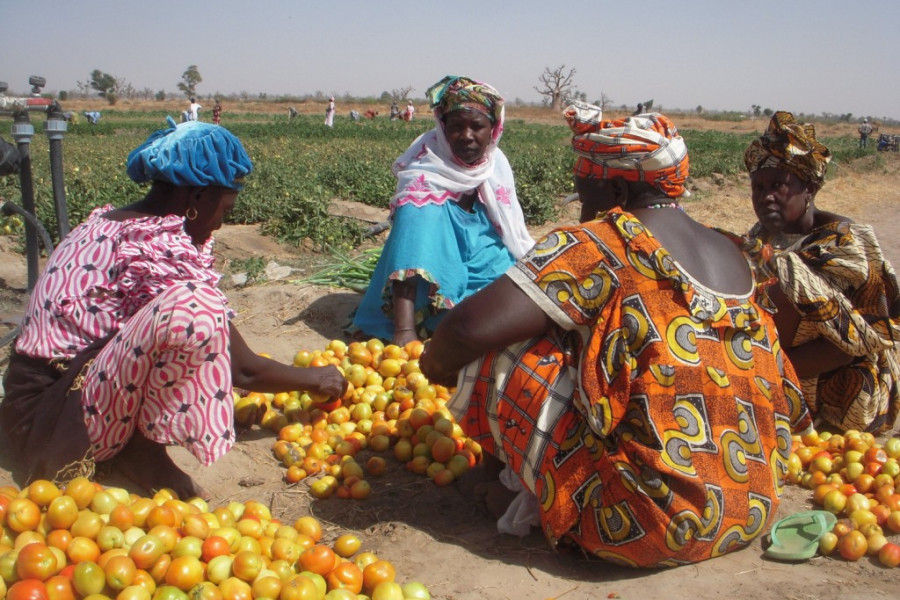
127,117,253,190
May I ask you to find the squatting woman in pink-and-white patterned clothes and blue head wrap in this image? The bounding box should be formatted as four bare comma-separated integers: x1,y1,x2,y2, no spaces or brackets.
0,119,344,498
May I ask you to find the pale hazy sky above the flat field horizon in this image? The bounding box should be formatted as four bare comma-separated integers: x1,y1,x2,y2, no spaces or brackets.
0,0,900,119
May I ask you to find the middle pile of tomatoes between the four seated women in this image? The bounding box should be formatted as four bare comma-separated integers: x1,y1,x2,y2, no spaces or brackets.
235,339,481,500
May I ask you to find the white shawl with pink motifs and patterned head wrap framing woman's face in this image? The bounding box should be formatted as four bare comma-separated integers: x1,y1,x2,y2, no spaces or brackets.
390,76,534,259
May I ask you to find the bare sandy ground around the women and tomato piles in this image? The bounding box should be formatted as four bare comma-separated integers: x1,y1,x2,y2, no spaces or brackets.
0,124,900,600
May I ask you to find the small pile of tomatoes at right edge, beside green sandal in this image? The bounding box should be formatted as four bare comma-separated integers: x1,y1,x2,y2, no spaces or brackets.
788,430,900,567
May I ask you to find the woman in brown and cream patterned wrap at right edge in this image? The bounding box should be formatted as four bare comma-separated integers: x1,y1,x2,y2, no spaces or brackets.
744,111,900,433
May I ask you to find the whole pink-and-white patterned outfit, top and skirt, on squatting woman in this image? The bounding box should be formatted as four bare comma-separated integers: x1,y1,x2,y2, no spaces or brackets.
16,205,234,464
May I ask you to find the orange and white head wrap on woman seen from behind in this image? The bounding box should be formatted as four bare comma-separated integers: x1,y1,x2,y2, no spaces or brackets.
563,102,689,198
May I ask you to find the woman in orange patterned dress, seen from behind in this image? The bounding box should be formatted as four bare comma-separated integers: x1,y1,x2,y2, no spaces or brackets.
421,103,810,567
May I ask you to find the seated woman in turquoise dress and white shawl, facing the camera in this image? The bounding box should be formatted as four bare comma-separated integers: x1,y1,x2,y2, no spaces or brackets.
352,76,534,346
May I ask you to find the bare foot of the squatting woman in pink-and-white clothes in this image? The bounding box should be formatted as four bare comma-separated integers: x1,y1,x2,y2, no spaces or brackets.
110,431,210,500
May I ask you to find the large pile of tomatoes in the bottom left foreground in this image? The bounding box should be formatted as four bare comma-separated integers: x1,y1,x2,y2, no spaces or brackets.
0,477,430,600
